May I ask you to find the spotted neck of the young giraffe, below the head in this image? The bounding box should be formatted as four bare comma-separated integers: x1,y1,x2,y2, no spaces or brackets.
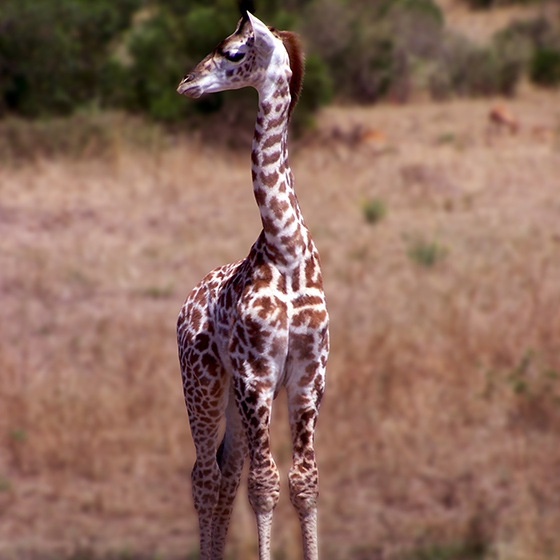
251,74,308,268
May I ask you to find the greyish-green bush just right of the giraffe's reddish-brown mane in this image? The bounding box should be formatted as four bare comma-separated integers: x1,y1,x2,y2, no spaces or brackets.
303,0,443,103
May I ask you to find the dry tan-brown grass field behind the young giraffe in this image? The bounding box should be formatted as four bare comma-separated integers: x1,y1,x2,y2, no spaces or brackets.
0,91,560,560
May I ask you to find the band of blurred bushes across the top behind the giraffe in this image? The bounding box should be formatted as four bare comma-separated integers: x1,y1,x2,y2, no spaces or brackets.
0,0,560,125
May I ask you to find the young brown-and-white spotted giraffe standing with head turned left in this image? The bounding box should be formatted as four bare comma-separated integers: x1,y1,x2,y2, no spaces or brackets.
177,12,329,560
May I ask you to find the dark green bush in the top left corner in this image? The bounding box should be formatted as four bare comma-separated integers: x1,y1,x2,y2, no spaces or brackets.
0,0,141,117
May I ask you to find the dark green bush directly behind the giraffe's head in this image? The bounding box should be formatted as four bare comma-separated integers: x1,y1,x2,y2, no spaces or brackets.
117,0,332,123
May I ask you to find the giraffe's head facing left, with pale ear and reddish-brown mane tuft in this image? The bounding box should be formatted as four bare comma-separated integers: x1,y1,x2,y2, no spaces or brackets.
177,12,304,116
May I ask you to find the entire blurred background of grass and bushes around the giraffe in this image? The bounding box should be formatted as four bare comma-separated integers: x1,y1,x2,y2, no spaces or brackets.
0,0,560,560
